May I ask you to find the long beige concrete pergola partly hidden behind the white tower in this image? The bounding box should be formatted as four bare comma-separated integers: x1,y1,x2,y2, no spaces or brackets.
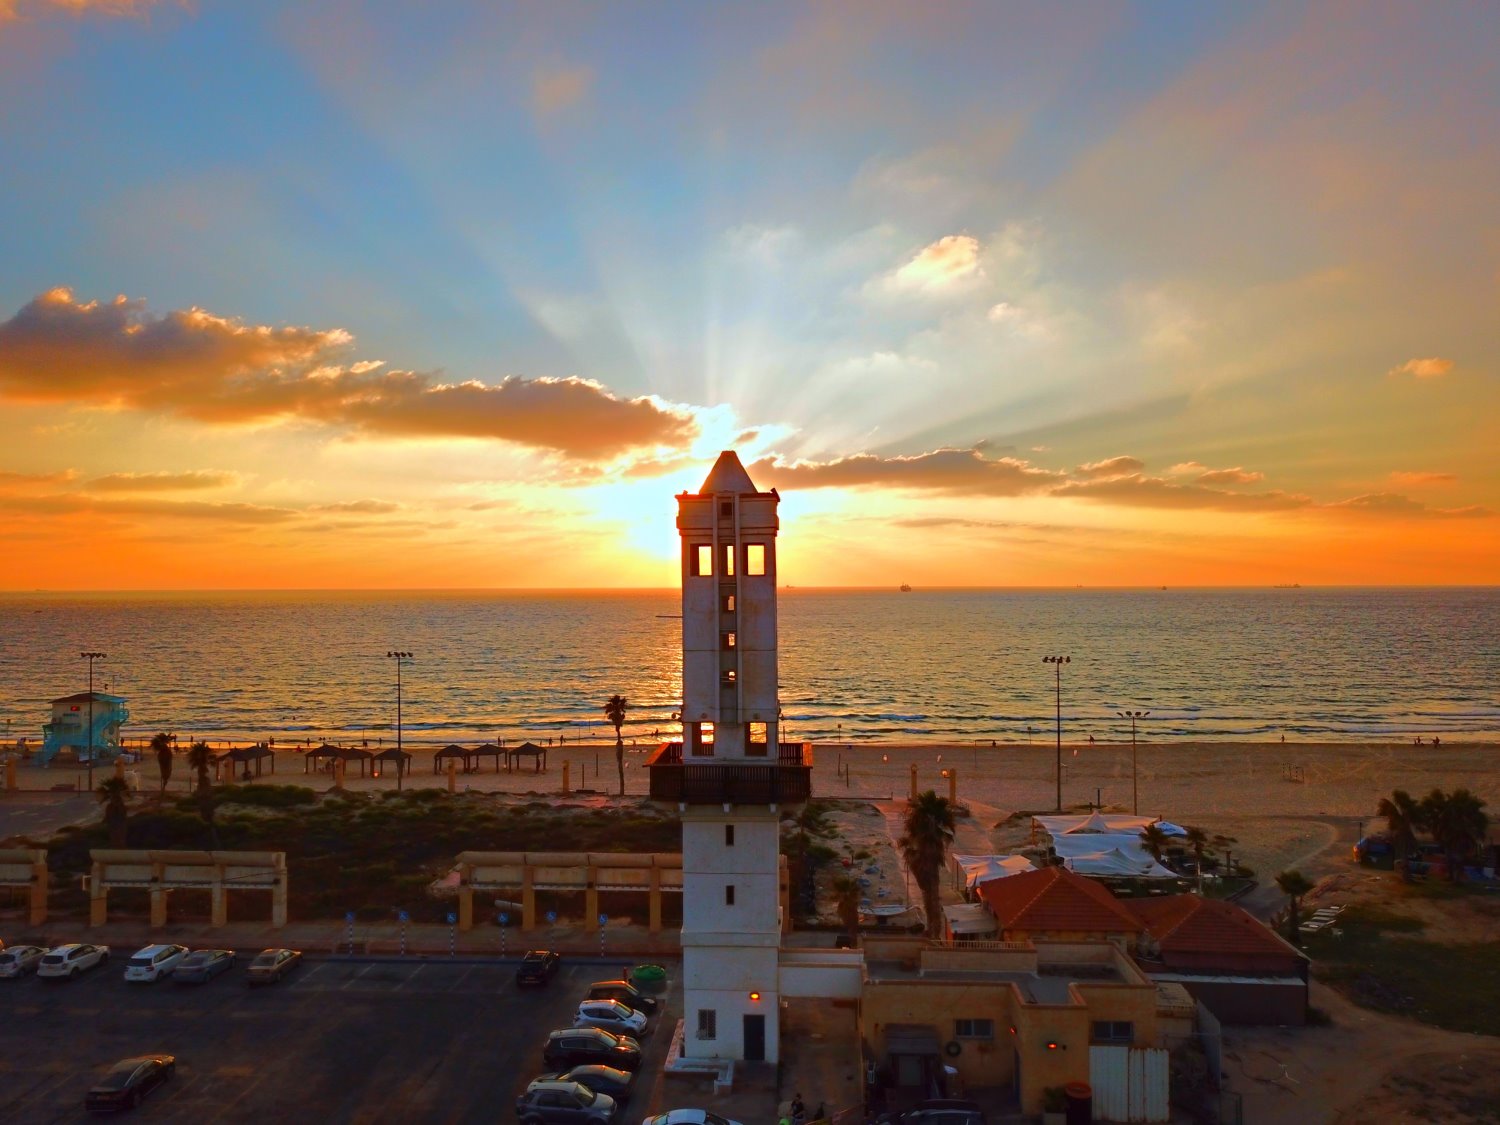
458,852,792,933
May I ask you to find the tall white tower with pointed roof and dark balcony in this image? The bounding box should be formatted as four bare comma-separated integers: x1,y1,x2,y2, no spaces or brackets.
650,450,812,1062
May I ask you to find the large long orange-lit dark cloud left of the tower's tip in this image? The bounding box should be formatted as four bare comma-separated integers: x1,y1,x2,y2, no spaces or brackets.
0,290,696,459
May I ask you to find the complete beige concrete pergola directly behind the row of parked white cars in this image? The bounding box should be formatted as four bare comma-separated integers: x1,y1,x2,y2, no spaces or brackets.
89,849,287,929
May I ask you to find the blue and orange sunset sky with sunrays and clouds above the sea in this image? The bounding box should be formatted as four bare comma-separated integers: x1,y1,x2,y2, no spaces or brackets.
0,0,1500,590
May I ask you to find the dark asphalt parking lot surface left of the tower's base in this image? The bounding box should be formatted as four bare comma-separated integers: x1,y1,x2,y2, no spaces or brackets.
0,950,681,1125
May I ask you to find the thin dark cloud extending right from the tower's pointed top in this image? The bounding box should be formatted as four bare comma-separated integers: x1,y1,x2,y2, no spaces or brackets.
749,449,1067,497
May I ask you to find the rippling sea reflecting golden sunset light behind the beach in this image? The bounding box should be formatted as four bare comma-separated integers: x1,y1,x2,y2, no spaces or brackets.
0,587,1500,747
